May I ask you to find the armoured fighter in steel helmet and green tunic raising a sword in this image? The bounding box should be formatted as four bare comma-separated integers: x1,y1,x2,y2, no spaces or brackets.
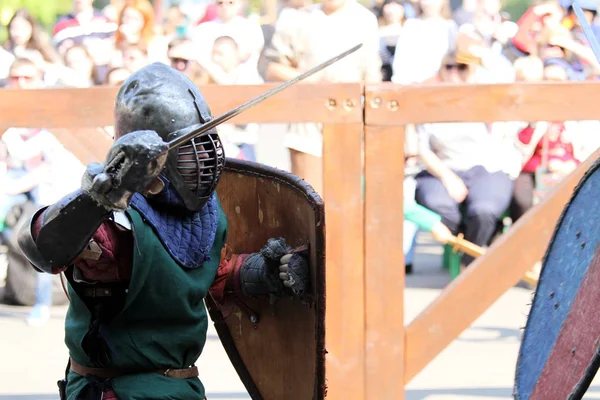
19,63,308,400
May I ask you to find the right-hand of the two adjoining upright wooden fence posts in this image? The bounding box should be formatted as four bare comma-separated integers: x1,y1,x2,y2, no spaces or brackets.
364,126,404,400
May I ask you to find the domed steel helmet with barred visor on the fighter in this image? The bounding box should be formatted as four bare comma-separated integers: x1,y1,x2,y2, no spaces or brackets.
115,63,225,211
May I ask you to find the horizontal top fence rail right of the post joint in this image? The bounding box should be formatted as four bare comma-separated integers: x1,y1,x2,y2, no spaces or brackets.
366,81,600,126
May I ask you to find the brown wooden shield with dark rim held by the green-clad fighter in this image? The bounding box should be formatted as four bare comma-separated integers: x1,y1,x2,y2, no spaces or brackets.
206,158,326,400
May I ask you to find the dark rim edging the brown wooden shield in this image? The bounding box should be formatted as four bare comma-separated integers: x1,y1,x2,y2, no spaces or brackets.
206,158,327,400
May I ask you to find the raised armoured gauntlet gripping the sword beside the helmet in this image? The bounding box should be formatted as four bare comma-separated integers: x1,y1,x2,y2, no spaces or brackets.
81,131,168,211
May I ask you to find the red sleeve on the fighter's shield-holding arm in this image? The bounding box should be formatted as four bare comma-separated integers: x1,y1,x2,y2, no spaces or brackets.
209,245,249,306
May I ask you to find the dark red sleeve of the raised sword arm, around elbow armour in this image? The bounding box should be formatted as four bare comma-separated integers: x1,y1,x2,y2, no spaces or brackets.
32,209,133,282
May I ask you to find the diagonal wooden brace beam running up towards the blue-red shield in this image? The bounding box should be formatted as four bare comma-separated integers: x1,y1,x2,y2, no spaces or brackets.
404,150,600,383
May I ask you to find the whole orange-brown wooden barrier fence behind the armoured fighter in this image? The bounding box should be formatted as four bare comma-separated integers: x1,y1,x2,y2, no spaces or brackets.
0,83,600,400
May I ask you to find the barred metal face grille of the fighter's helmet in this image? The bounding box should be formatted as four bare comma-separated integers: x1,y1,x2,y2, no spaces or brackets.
177,133,225,198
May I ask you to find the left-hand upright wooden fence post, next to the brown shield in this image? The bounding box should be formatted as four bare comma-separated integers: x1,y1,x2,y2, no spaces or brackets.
323,124,366,400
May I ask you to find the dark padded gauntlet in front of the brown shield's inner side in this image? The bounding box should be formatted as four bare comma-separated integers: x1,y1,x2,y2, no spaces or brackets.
240,238,310,296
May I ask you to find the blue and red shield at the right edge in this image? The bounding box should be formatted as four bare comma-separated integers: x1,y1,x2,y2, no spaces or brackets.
515,162,600,400
